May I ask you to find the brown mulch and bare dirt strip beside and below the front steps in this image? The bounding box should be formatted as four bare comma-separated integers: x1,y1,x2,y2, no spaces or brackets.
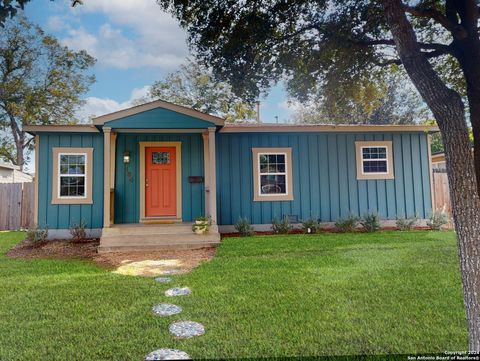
7,239,215,273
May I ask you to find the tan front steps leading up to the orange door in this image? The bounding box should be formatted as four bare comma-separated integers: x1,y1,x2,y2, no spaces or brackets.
98,223,220,253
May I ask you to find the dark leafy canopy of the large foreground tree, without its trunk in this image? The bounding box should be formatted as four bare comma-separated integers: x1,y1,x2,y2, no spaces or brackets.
158,0,465,108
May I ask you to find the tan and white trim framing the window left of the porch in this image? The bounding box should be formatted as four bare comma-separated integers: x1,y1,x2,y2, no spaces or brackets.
51,147,93,204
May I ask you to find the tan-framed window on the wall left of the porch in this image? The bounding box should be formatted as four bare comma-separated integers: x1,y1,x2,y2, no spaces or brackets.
52,148,93,204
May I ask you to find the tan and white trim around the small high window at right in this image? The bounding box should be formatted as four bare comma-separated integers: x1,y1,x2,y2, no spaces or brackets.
355,141,394,180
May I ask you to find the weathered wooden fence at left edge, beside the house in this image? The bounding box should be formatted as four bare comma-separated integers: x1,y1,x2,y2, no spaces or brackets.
0,182,35,231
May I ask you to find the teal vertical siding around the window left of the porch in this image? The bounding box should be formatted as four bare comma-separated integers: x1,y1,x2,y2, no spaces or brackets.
37,133,103,229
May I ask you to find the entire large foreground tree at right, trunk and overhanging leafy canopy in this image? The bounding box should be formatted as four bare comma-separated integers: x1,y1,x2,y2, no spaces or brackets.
158,0,480,352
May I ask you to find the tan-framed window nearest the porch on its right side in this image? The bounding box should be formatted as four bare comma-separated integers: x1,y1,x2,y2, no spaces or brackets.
252,148,293,201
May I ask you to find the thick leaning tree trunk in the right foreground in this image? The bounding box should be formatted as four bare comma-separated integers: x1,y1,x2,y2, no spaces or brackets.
383,0,480,352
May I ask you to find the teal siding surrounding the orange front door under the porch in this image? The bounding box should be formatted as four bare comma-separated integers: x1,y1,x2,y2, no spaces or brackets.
114,133,205,224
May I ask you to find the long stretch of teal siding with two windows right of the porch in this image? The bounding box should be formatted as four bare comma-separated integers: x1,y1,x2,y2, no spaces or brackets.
217,132,432,225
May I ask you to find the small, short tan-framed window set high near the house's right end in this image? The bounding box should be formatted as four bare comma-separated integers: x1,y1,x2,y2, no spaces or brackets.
355,141,393,179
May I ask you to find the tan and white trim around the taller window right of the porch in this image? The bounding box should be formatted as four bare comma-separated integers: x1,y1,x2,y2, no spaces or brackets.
252,148,293,201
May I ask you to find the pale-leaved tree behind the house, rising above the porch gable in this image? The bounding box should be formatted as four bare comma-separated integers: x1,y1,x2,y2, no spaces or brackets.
136,60,255,121
